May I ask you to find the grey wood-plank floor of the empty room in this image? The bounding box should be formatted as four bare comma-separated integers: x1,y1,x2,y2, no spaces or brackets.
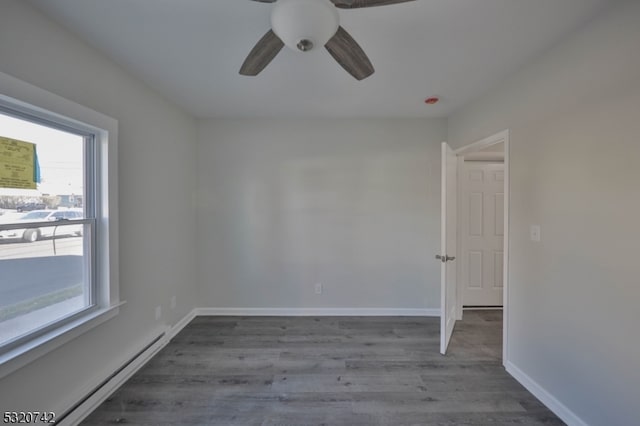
83,311,564,426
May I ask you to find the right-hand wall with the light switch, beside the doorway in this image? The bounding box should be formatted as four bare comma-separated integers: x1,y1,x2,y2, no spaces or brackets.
449,1,640,426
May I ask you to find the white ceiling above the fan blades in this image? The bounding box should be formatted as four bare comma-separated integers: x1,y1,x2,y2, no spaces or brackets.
30,0,613,117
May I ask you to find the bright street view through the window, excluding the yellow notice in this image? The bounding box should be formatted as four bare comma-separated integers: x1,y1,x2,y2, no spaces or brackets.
0,111,95,352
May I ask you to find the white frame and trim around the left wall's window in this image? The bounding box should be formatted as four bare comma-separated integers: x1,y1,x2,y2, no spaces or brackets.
0,73,124,378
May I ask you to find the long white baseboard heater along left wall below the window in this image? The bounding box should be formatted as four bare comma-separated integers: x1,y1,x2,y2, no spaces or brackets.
57,309,196,426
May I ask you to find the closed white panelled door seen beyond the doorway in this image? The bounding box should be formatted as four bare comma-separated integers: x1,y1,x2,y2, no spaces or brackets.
458,161,504,306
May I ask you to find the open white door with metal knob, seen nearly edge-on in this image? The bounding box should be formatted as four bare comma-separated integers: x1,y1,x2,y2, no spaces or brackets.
436,142,458,355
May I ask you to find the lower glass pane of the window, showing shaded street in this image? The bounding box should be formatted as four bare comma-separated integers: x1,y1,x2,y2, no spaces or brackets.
0,224,91,345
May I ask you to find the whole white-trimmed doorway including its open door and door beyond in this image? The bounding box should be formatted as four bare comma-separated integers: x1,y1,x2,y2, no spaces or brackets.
437,130,509,364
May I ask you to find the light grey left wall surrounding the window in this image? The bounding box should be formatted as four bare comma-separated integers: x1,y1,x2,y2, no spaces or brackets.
0,0,196,415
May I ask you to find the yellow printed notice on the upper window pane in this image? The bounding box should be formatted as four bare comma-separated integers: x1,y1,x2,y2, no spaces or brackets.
0,136,37,189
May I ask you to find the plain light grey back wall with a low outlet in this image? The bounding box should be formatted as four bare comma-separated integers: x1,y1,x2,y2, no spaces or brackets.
198,119,446,309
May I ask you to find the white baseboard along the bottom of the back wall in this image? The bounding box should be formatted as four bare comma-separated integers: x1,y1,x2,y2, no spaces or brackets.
195,308,440,317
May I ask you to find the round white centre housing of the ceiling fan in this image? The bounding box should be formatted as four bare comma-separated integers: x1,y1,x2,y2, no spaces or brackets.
271,0,340,52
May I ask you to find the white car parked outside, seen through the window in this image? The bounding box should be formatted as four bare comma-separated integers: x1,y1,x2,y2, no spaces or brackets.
0,210,83,243
